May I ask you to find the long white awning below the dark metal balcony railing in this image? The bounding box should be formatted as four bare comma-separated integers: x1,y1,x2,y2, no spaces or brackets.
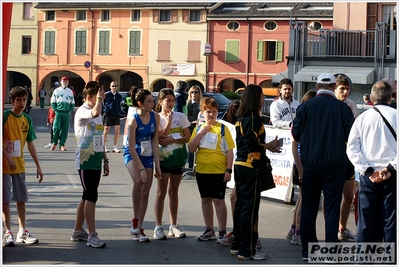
294,66,375,84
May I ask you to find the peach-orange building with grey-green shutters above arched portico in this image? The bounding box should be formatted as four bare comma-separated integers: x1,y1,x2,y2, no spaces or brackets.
36,3,150,100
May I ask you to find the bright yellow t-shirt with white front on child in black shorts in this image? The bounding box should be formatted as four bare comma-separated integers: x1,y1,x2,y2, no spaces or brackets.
190,122,235,174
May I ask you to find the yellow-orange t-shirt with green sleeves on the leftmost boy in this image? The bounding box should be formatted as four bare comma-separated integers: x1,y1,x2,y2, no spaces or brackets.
3,110,36,174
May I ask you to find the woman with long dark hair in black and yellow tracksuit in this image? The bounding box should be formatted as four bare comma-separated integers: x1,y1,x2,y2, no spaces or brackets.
230,84,280,260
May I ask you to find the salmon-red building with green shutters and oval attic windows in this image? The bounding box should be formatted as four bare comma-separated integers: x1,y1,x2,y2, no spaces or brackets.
207,2,333,92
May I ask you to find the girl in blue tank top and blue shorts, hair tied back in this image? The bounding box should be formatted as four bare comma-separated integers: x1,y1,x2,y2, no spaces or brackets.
123,88,161,242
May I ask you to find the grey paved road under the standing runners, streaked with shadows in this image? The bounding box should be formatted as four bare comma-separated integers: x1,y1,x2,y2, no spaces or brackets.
2,105,355,265
